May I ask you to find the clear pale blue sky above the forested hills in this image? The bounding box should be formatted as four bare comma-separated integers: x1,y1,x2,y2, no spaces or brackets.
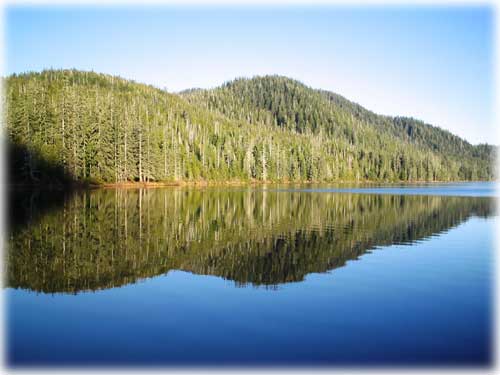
6,6,496,143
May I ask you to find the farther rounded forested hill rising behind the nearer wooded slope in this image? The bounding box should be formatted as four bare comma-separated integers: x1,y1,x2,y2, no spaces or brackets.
182,76,493,170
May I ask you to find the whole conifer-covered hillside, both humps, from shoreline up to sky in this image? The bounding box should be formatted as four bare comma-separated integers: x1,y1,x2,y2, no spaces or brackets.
4,70,496,184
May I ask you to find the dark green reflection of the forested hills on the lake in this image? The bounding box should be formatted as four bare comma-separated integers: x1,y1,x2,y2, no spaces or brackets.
6,189,493,293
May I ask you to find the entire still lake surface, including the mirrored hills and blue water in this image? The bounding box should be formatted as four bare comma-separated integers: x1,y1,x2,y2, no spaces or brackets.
4,183,499,367
